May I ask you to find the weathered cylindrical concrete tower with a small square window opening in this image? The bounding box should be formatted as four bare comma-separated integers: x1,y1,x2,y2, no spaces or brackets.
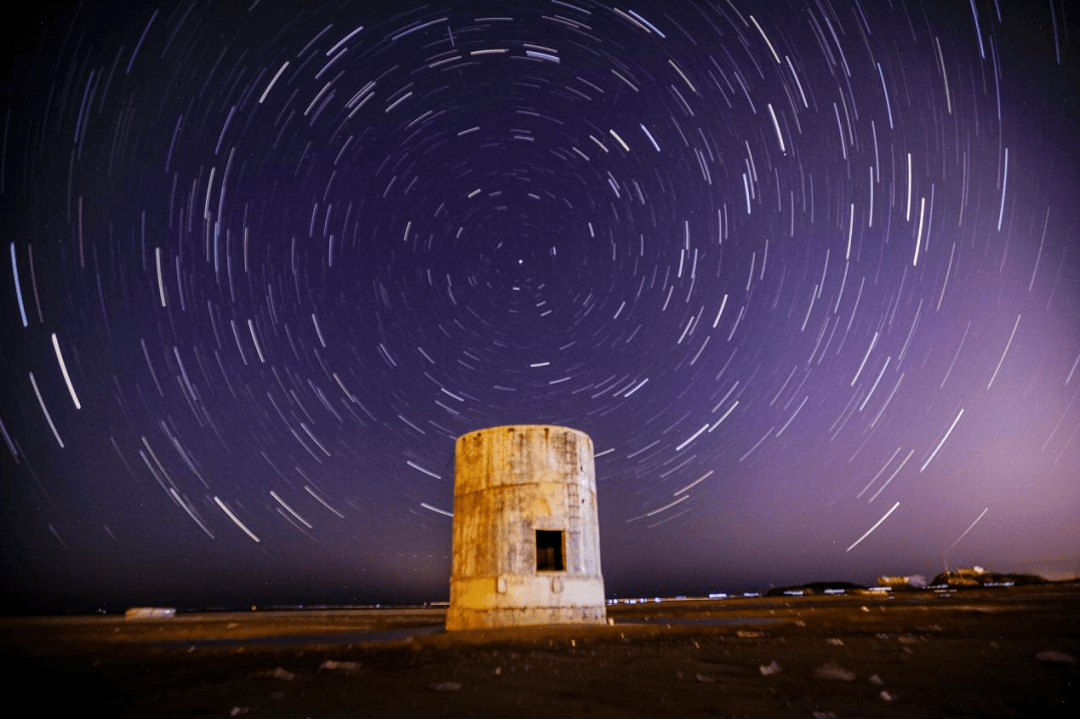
446,424,605,629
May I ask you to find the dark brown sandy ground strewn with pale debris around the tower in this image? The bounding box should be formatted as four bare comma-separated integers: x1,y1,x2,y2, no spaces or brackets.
0,583,1080,719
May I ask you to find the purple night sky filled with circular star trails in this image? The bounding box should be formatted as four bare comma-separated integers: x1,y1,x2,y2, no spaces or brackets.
0,0,1080,611
